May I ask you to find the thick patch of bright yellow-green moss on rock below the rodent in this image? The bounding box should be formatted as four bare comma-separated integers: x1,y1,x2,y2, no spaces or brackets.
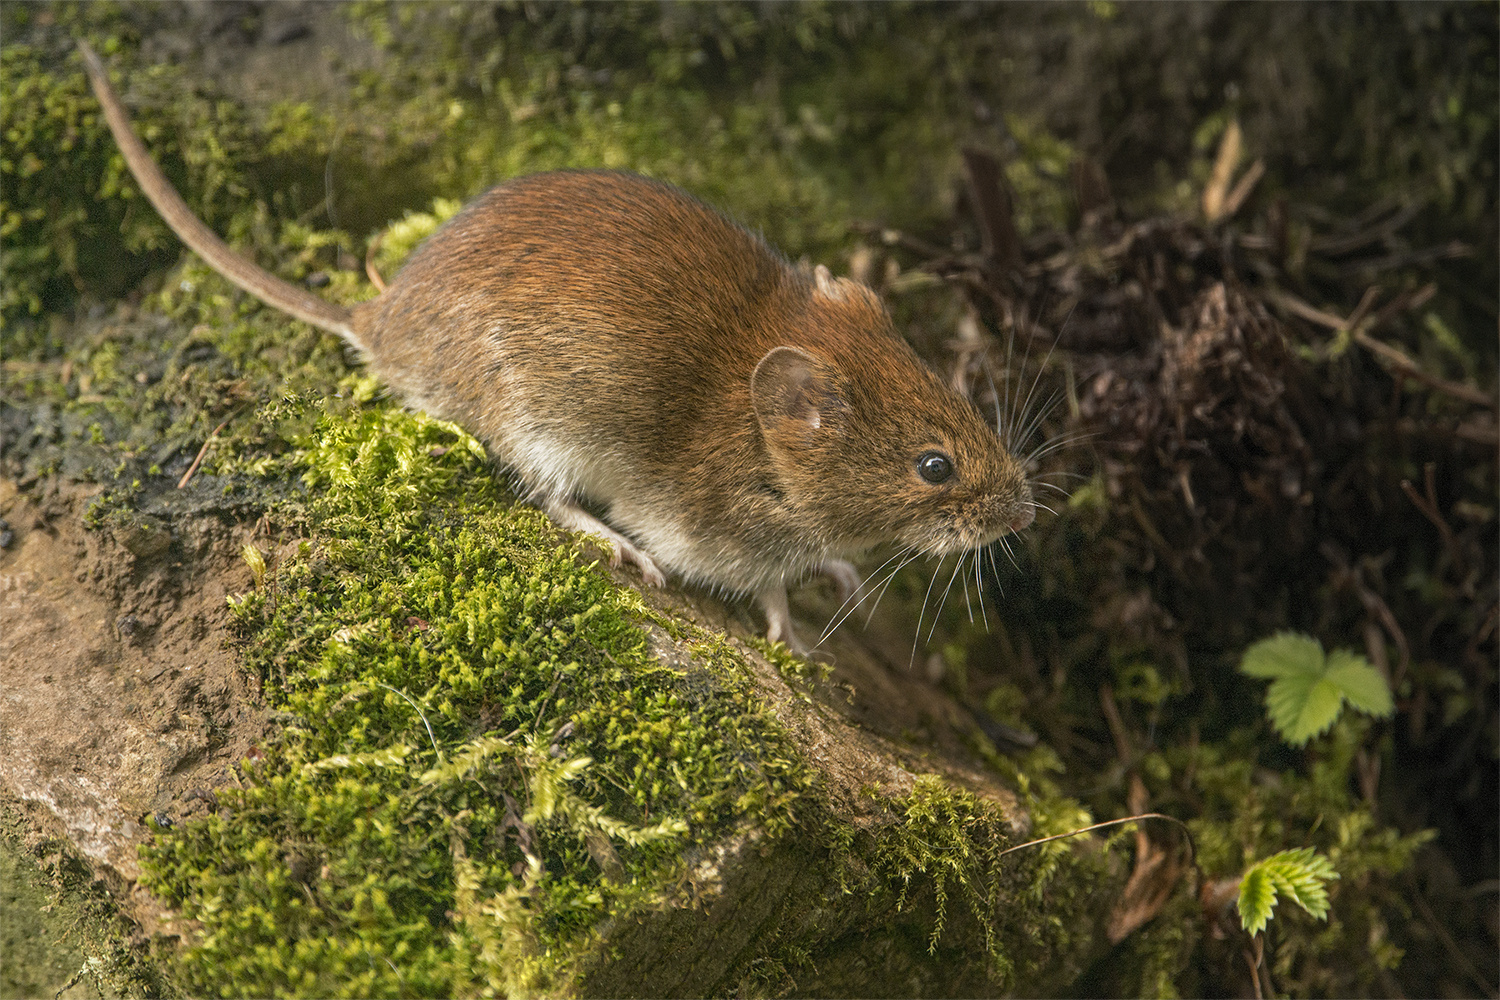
144,408,809,996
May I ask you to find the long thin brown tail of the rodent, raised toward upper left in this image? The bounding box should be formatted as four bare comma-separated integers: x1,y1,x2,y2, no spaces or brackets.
78,42,363,348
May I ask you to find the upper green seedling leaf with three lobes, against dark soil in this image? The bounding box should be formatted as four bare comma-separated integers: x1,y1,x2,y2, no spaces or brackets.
1239,633,1395,747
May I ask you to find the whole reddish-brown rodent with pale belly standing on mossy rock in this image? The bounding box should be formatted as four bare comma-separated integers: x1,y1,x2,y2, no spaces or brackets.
80,45,1035,649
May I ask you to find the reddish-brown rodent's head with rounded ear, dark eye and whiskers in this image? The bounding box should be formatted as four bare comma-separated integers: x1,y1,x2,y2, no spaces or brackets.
750,274,1037,555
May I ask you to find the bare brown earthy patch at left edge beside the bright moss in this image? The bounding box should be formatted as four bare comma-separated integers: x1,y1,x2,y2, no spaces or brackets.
0,480,266,928
